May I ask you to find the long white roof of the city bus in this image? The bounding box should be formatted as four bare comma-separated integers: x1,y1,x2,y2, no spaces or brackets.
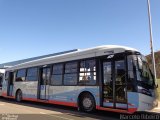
6,45,138,70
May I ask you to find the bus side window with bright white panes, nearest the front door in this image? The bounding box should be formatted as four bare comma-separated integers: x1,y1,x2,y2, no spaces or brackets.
79,60,96,85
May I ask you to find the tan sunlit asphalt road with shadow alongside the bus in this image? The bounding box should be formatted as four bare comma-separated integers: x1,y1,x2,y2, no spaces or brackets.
0,98,160,120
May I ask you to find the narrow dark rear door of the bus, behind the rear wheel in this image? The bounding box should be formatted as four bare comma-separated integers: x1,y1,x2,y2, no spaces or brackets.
7,72,14,96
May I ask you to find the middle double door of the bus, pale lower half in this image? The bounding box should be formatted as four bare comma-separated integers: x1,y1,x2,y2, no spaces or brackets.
39,67,50,100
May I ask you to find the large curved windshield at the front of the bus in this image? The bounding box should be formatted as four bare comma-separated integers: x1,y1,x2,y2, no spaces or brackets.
137,55,154,88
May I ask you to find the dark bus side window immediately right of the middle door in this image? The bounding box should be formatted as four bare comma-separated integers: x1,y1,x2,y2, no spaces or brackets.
51,64,63,85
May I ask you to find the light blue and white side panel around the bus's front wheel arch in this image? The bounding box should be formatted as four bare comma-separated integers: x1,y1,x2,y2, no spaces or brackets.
49,86,99,106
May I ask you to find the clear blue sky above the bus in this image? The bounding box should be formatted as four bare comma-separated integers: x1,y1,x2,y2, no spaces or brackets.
0,0,160,63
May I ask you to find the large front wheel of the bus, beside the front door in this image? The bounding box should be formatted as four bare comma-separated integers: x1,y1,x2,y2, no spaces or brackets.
79,93,96,113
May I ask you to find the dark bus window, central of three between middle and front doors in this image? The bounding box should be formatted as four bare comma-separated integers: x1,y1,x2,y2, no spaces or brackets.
64,62,78,85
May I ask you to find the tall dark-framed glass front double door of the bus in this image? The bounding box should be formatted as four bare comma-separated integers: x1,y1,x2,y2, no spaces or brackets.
102,55,128,109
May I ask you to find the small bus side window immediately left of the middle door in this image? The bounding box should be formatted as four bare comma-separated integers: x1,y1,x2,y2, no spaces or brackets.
26,68,38,81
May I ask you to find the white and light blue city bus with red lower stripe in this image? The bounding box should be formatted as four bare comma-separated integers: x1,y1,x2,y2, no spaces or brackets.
2,45,158,114
